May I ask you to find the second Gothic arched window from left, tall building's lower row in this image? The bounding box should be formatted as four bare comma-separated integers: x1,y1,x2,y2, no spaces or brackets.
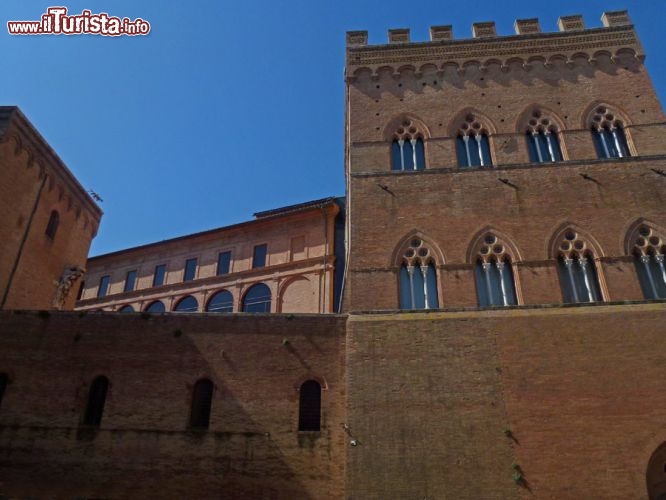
474,233,518,307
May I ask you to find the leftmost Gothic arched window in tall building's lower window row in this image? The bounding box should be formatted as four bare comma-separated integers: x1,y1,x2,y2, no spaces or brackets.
399,238,439,309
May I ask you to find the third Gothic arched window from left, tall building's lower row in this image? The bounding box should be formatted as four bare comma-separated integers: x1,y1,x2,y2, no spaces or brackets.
557,229,601,303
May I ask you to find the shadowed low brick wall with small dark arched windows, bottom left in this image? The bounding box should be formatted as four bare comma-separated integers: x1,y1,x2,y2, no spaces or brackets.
0,313,345,499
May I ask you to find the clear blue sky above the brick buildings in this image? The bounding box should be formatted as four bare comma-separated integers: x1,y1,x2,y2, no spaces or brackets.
5,0,666,255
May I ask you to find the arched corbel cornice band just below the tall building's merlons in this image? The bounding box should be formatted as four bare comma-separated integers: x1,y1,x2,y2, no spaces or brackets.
346,25,644,80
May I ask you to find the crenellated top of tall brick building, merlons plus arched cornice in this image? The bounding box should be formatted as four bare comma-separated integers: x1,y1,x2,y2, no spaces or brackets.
346,10,645,81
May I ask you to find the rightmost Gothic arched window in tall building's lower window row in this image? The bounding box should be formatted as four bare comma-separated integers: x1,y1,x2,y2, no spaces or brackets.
633,225,666,299
